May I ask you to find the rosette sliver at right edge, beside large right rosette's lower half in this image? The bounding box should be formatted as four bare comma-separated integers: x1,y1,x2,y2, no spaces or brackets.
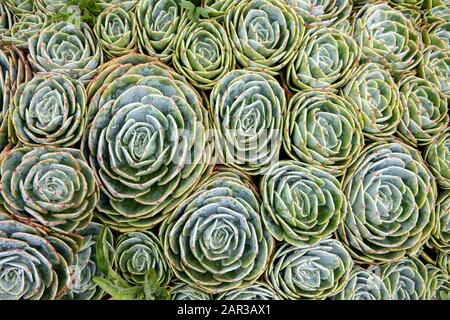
431,191,450,250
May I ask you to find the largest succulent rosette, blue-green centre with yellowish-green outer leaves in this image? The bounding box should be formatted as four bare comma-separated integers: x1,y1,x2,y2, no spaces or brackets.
82,54,214,232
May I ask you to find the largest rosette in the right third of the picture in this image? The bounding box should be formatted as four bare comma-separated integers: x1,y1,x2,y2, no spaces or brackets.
338,141,437,264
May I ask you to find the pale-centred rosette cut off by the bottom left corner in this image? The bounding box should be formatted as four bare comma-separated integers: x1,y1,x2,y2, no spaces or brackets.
0,213,82,300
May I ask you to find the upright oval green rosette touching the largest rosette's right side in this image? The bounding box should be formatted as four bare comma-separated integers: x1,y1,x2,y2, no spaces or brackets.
210,69,287,175
